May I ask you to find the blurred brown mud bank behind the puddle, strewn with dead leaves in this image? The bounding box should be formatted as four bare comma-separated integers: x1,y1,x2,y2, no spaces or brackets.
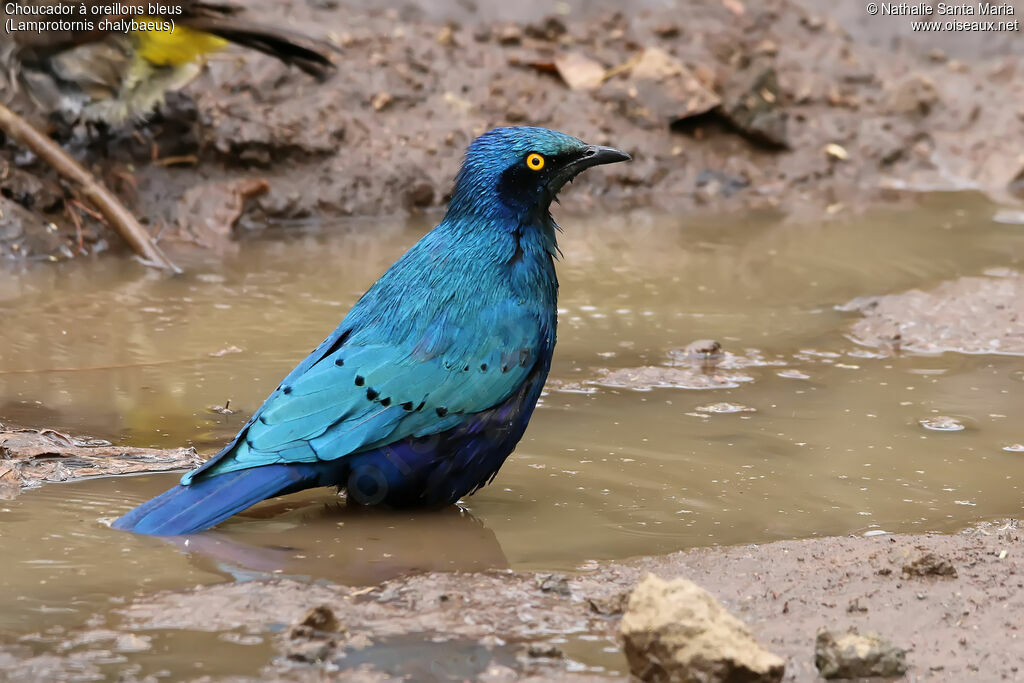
0,0,1024,259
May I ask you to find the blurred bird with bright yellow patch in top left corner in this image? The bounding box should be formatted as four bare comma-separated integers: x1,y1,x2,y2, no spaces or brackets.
0,0,335,125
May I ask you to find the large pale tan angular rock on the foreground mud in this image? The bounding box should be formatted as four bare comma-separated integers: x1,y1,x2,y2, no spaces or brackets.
621,574,785,683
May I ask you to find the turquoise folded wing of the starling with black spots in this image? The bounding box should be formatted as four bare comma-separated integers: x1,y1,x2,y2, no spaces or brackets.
188,301,547,484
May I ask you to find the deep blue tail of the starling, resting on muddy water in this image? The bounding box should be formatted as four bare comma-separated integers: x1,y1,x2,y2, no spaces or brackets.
114,463,337,536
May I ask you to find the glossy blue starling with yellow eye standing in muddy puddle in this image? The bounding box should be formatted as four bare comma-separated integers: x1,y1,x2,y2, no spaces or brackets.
115,127,628,535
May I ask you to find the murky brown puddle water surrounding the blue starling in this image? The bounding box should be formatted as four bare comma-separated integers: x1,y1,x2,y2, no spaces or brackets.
0,195,1024,675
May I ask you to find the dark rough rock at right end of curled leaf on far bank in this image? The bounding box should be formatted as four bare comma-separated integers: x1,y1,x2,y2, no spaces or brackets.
722,59,790,150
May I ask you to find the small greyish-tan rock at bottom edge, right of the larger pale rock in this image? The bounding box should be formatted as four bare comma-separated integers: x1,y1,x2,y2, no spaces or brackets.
814,630,906,678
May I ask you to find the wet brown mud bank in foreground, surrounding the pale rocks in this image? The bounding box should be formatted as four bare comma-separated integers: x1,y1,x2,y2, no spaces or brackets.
0,521,1024,681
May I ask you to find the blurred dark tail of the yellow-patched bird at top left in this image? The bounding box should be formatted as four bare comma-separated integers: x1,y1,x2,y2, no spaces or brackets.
188,16,337,80
